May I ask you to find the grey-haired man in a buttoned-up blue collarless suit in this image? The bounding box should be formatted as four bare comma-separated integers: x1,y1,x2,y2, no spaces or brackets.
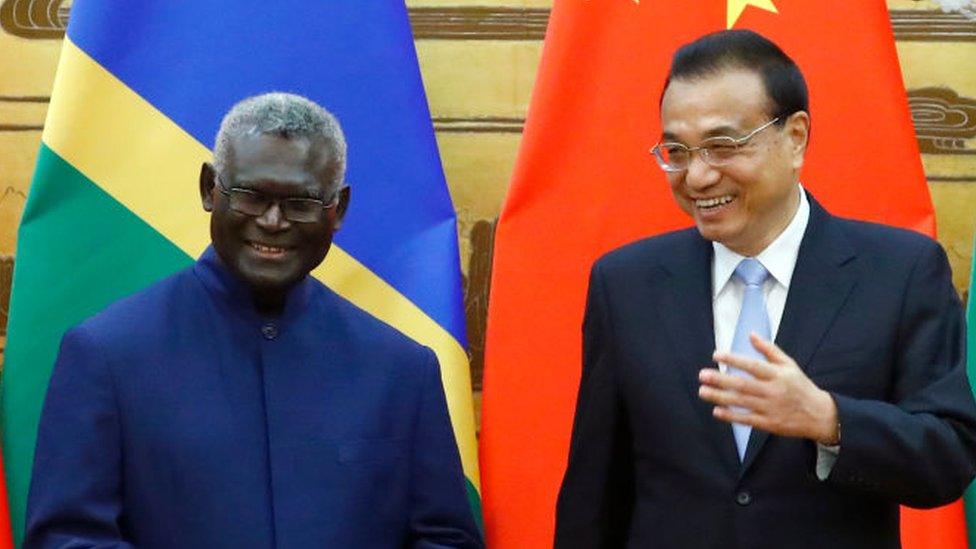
24,94,482,548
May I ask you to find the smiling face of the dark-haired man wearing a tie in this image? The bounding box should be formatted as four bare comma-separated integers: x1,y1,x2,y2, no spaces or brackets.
661,68,810,256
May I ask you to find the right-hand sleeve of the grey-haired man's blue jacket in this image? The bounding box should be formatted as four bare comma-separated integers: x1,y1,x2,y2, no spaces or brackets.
408,350,484,549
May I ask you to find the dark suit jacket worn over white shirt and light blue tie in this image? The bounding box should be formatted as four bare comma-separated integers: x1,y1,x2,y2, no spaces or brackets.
556,198,976,549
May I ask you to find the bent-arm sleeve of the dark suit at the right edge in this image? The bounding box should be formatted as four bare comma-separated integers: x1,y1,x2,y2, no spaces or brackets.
828,242,976,507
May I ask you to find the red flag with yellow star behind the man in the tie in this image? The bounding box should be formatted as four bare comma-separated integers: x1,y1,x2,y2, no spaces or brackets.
480,0,966,549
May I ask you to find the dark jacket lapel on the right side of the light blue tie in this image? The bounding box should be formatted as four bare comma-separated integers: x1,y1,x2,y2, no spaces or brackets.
742,193,857,473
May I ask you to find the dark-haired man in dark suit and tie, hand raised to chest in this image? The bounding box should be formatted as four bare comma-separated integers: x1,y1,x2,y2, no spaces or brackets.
556,31,976,549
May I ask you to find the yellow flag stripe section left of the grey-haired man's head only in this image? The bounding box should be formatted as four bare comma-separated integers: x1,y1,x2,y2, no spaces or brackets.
41,43,211,258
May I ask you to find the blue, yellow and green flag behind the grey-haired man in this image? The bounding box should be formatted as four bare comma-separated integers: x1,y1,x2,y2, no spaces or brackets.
3,0,480,543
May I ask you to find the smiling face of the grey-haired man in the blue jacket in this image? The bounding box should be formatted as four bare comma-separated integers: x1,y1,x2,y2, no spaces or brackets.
200,134,349,308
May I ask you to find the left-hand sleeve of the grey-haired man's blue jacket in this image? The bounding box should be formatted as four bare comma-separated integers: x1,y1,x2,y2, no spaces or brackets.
23,328,131,549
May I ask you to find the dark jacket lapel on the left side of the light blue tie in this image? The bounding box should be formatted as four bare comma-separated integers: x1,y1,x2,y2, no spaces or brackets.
660,229,739,472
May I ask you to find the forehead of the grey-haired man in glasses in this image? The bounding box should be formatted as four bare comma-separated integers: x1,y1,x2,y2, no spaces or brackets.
228,134,335,183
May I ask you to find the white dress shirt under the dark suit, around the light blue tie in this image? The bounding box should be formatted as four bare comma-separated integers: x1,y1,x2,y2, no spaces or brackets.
712,185,840,480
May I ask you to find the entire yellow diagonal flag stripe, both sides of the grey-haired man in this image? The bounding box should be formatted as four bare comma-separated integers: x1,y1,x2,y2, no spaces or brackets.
42,38,481,492
